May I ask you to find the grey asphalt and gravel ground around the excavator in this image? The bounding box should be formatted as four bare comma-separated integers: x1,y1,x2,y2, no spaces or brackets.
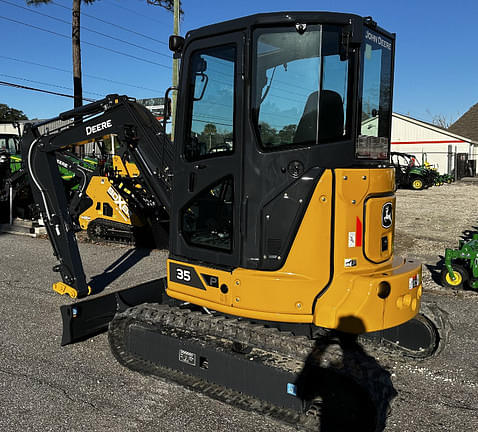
0,183,478,432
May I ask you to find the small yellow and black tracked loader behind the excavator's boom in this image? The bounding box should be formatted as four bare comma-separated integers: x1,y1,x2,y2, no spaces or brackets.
57,137,167,247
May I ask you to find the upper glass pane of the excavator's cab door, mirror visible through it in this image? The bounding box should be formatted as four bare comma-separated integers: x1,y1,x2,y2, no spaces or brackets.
184,45,236,161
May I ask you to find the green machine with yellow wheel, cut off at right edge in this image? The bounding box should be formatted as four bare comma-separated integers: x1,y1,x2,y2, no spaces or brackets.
441,234,478,289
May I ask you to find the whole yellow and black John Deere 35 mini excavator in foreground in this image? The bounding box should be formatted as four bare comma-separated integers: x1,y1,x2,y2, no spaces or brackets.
22,12,446,430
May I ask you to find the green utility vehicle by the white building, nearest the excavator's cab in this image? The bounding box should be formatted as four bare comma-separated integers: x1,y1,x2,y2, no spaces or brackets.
391,152,435,190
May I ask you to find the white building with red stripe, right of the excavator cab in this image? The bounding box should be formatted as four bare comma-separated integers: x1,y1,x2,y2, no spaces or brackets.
391,113,478,174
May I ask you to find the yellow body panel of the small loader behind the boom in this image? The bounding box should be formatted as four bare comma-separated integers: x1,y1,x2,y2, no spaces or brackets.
78,176,135,230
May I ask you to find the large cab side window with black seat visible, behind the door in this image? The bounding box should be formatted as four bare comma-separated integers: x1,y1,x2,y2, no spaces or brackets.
252,25,349,149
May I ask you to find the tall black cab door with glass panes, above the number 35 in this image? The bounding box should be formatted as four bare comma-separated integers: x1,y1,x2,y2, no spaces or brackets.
170,33,244,268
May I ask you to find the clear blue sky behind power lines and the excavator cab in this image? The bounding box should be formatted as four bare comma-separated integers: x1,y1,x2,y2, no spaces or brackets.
0,0,478,122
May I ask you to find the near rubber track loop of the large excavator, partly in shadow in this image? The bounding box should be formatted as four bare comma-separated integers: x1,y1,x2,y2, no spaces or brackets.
108,304,395,431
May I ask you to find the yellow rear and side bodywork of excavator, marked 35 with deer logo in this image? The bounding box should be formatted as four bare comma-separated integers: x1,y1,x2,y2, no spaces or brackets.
167,168,421,333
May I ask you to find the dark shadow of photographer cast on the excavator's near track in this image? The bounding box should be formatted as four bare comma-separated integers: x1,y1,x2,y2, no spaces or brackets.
296,317,397,432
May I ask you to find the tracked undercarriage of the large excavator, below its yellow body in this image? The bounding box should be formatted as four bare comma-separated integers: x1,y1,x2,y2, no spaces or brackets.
81,284,447,431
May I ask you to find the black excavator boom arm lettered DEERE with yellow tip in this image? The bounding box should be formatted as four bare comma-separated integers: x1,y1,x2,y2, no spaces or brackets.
21,95,173,298
